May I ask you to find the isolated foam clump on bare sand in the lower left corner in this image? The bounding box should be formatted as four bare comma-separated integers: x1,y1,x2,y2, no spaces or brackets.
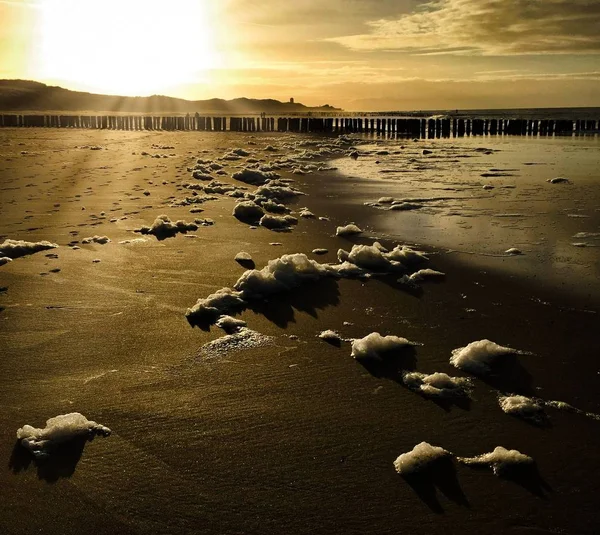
17,412,111,459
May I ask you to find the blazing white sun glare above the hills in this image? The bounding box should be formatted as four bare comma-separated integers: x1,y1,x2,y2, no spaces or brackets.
38,0,220,95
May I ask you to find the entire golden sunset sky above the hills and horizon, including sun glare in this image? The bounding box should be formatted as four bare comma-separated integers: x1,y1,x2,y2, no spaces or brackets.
0,0,600,110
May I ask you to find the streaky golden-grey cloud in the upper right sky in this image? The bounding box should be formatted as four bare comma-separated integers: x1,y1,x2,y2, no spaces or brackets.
327,0,600,55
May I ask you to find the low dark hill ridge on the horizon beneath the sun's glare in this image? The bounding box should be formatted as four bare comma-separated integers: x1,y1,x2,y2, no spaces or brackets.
0,80,340,114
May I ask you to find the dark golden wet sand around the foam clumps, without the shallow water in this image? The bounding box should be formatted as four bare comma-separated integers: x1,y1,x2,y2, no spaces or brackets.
0,129,600,534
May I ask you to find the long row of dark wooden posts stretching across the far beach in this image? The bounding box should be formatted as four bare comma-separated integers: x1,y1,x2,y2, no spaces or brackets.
0,114,599,138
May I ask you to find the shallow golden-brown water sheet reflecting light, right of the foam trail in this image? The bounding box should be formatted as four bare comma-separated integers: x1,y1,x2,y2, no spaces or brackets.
336,136,600,301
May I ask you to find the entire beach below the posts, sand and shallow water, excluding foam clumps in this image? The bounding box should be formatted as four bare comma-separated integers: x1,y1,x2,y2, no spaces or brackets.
0,128,600,534
